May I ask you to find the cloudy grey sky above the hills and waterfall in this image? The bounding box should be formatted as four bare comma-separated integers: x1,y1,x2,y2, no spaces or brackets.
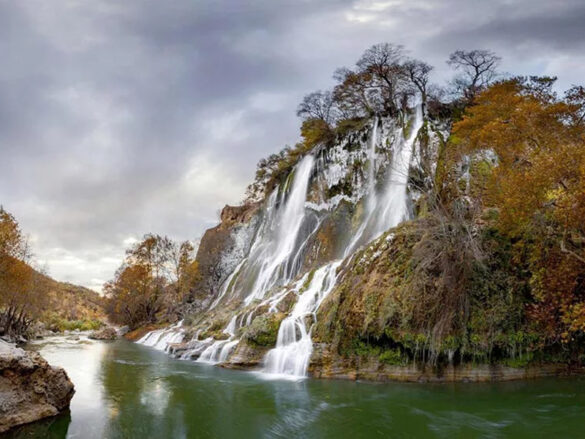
0,0,585,291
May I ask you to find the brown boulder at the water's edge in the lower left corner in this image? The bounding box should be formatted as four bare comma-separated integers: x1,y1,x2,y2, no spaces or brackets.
0,341,75,433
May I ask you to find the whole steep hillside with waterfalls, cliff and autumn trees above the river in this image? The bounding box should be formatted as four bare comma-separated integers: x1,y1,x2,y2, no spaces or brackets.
112,45,585,380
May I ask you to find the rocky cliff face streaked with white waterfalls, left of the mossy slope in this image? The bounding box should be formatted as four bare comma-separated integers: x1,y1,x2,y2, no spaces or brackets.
137,110,470,382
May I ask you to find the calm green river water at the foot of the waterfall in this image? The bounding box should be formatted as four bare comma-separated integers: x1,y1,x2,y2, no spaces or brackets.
1,337,585,439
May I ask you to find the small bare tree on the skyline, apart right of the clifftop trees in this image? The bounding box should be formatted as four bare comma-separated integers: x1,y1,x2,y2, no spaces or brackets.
447,50,501,102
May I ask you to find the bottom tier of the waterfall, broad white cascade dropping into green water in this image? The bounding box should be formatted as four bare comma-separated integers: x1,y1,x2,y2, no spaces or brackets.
264,261,341,378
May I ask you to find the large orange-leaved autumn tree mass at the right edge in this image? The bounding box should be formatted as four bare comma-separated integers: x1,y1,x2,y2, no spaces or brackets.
453,78,585,340
